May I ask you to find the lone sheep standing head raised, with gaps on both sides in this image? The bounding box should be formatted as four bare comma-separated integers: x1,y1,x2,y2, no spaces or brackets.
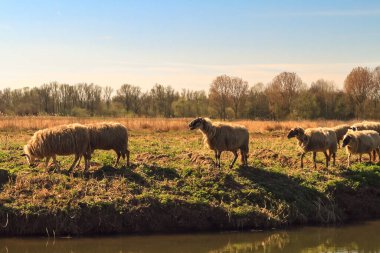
189,117,249,169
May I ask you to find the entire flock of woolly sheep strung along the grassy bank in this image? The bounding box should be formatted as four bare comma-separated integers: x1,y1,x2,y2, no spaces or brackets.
22,118,380,172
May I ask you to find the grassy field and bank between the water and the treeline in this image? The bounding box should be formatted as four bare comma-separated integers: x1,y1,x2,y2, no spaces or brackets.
0,117,380,235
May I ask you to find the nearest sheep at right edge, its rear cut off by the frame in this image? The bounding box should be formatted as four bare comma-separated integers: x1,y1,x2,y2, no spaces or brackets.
342,130,380,167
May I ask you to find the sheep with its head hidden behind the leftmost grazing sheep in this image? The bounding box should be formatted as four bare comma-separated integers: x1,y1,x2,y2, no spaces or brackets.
87,122,129,166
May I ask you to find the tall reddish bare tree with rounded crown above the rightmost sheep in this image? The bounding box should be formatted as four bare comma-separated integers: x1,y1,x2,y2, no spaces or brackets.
344,67,376,118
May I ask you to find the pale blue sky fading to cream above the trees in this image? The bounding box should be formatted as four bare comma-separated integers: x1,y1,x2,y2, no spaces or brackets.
0,0,380,90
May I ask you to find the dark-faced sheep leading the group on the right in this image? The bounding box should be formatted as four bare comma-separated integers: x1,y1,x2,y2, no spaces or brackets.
287,127,337,169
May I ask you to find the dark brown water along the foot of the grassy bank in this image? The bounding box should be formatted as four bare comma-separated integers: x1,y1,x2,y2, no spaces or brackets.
0,220,380,253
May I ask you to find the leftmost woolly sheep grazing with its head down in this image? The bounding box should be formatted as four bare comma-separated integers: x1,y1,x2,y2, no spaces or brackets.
22,124,91,172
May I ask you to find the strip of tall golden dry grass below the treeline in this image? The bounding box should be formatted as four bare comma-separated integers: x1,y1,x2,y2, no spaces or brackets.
0,116,352,132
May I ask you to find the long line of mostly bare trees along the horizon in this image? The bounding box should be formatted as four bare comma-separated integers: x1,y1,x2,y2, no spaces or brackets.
0,66,380,120
